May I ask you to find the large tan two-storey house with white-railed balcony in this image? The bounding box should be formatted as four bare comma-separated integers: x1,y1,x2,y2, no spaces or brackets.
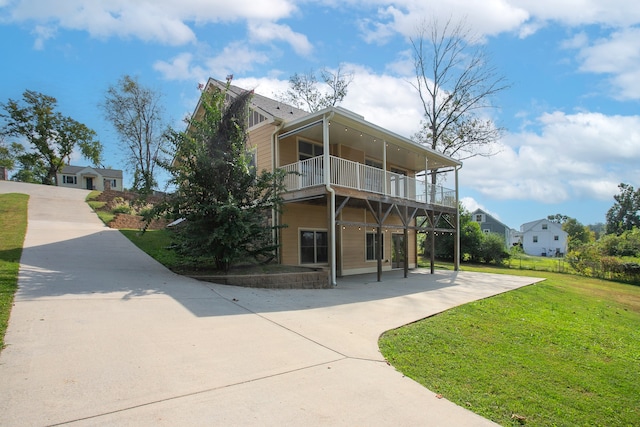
194,79,462,285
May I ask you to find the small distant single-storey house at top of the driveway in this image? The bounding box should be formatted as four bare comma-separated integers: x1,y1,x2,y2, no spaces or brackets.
56,166,123,191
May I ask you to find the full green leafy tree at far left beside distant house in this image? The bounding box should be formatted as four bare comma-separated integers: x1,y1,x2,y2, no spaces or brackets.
0,90,102,185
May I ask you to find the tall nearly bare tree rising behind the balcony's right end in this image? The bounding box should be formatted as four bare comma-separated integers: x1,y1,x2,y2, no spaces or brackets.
411,20,509,184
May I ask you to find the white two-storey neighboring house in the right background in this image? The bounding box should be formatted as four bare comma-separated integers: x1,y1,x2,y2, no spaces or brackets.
520,219,568,257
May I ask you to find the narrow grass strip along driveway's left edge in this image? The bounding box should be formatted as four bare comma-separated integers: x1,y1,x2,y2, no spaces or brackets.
0,193,29,350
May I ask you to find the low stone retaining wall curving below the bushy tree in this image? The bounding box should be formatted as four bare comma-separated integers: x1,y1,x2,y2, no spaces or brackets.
189,271,331,289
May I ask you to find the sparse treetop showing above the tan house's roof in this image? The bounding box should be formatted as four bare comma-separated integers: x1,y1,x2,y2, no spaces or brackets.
276,68,353,113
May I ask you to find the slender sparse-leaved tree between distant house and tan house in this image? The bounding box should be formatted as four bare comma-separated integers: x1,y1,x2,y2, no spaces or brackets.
102,75,168,194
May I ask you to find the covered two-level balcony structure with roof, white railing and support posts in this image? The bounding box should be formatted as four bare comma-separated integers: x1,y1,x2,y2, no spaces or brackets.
273,107,462,284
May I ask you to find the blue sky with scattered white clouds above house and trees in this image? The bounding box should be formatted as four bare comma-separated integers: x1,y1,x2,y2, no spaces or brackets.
0,0,640,229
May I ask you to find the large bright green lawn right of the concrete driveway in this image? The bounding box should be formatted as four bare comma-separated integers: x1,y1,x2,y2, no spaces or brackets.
380,268,640,426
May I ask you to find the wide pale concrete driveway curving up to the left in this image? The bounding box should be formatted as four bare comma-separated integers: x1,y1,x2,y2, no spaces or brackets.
0,181,537,426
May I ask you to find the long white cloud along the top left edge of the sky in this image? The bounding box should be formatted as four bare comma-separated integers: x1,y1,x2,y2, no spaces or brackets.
5,0,296,45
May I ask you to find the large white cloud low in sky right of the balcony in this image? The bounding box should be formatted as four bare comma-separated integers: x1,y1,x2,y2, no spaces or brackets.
461,112,640,203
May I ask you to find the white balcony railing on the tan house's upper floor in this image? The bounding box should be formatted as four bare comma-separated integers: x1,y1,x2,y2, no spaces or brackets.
282,156,456,208
